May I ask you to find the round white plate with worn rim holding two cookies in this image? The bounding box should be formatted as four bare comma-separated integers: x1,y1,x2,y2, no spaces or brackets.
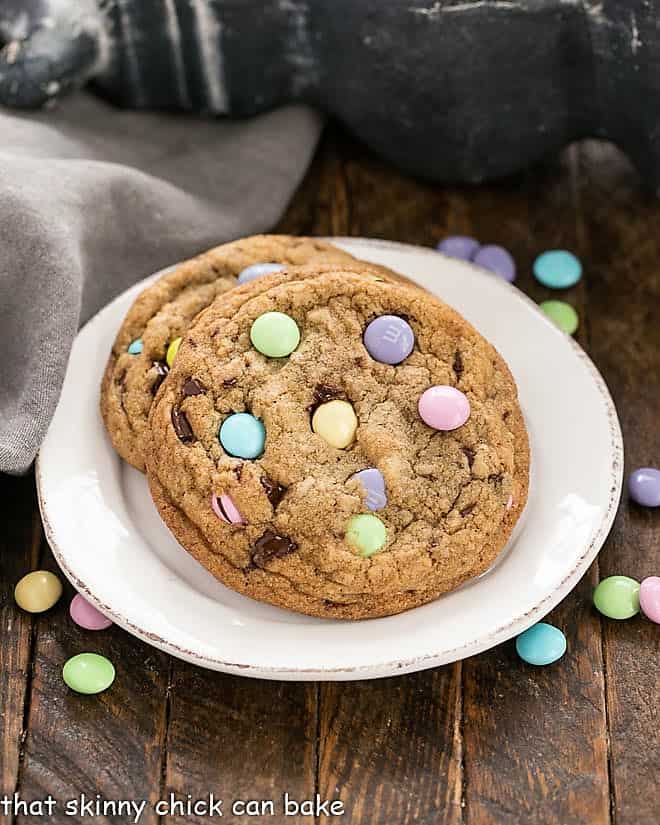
37,239,623,679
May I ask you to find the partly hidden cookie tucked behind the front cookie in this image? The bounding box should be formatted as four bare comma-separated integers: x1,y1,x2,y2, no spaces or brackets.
101,235,364,470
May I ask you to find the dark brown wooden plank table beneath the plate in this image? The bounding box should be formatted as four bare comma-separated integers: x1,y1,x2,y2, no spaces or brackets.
0,127,660,825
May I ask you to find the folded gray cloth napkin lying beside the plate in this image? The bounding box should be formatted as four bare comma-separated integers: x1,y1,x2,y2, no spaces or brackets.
0,95,321,473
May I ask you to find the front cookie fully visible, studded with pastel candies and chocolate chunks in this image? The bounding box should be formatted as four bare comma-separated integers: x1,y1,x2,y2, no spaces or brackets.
148,267,529,619
